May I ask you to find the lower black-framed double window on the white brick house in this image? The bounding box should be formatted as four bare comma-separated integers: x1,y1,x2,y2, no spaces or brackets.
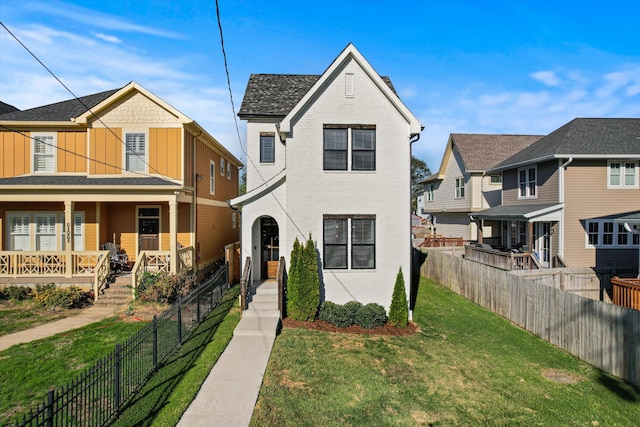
323,215,376,270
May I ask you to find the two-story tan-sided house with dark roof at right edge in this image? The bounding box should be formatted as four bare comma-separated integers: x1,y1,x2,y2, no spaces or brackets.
475,119,640,276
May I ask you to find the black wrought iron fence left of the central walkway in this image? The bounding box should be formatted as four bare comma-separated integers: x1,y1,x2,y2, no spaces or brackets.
13,265,229,427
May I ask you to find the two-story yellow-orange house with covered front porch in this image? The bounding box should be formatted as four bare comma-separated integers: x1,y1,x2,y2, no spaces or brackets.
0,82,242,298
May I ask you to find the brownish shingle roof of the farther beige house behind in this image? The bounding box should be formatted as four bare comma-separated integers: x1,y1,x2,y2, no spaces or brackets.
451,133,542,171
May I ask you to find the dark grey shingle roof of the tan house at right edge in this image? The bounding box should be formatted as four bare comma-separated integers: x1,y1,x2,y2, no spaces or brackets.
495,119,640,169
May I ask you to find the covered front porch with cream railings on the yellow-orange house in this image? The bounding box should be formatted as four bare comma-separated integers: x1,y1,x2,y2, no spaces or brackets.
0,184,195,298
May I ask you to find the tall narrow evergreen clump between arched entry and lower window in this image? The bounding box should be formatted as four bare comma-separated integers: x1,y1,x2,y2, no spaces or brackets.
287,235,320,321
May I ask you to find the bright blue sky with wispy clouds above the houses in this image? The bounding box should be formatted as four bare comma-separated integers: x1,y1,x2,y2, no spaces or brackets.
0,0,640,171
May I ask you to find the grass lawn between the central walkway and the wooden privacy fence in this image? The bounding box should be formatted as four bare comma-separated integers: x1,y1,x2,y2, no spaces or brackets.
251,279,640,426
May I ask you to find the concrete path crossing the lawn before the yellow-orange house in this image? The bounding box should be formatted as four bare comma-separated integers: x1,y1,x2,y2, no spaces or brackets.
0,305,123,351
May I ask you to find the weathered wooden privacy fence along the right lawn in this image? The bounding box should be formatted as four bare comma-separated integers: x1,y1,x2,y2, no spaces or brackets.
420,249,640,385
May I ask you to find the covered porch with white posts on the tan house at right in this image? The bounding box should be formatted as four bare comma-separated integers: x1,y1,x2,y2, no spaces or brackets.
465,204,566,270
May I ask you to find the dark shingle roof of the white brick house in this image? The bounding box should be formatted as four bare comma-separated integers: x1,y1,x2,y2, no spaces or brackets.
238,74,396,118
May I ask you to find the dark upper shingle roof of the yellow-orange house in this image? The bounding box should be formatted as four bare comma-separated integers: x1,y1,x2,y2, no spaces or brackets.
0,89,120,122
